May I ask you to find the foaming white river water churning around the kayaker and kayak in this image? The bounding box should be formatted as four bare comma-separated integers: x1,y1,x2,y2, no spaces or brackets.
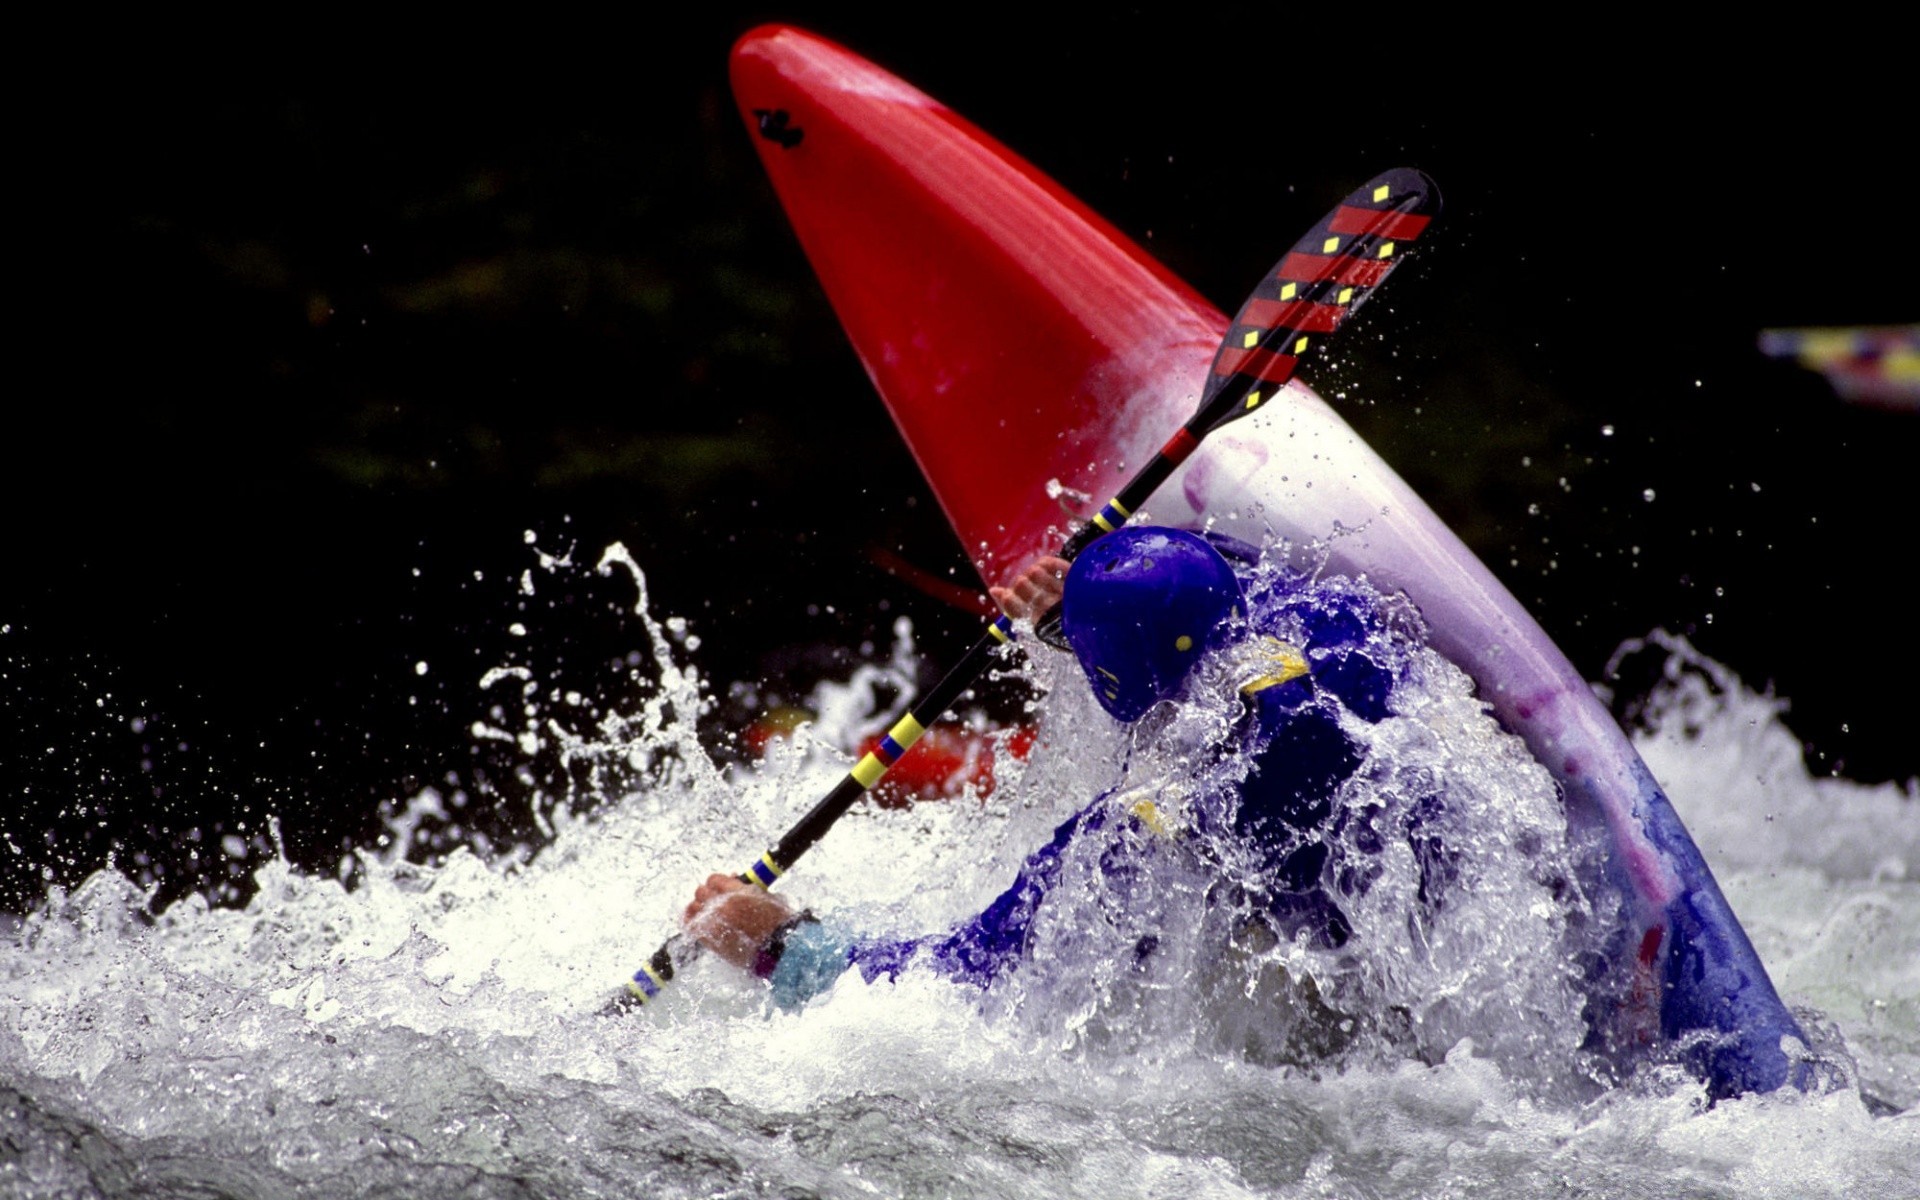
0,547,1920,1200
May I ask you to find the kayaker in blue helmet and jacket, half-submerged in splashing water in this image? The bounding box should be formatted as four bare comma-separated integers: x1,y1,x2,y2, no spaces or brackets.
684,526,1448,1029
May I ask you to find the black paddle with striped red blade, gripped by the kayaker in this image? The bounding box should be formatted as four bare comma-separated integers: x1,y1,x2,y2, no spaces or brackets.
616,169,1440,1004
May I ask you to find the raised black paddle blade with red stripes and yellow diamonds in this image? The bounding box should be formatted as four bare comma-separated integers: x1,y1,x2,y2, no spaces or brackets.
1200,167,1440,430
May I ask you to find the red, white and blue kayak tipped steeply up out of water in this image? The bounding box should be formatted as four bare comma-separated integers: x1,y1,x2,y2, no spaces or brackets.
732,25,1811,1096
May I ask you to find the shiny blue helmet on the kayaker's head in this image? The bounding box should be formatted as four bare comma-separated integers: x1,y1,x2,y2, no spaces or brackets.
1062,526,1244,720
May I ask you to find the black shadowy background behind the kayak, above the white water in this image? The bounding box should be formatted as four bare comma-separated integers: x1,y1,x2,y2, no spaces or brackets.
0,14,1920,910
